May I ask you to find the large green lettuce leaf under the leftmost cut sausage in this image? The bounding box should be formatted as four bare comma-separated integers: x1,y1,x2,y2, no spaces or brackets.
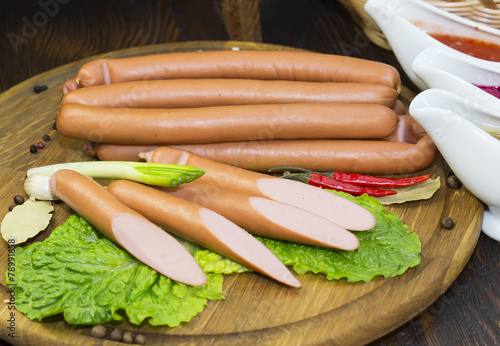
7,215,245,327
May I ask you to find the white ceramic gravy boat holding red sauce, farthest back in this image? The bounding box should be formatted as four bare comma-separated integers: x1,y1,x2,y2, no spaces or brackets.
364,0,500,90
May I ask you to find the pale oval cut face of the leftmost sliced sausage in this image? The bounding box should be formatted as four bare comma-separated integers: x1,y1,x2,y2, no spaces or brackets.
111,214,207,286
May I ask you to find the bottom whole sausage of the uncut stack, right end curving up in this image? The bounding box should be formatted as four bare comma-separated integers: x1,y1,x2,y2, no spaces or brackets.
94,127,438,174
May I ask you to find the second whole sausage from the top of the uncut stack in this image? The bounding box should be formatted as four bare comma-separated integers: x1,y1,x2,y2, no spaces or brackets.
62,79,398,108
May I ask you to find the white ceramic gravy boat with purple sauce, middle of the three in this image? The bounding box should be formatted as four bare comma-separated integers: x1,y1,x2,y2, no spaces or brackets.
412,48,500,110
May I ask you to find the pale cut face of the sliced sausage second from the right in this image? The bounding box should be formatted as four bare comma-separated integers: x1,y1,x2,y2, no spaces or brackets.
248,197,359,250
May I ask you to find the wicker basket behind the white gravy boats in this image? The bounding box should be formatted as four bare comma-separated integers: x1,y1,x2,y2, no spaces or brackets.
339,0,500,49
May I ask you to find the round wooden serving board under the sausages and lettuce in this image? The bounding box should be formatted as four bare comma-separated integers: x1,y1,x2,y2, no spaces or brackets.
0,42,483,345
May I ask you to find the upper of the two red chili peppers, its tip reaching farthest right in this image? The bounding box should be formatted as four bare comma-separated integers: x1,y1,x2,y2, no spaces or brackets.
333,171,430,188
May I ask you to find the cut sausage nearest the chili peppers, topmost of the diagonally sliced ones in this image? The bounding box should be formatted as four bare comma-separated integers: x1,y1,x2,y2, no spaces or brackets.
141,147,376,231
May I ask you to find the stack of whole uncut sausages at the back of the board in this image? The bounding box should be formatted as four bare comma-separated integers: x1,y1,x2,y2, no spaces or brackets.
57,51,437,174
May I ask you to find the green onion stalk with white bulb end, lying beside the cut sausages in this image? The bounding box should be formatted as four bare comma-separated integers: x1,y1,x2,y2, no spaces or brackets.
25,161,205,199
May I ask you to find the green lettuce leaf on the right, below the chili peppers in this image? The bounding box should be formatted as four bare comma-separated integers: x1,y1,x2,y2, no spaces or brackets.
259,190,421,282
